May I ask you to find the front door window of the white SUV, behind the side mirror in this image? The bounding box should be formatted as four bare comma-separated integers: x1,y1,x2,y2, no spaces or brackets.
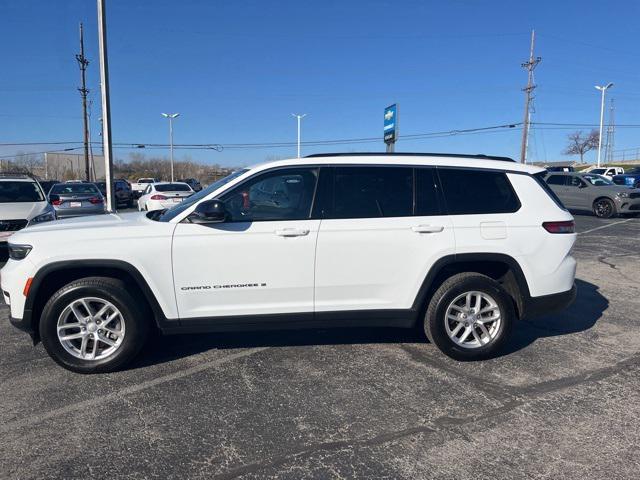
222,168,318,222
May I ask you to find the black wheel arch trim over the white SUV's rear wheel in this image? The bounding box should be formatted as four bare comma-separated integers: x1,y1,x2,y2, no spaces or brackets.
412,252,531,322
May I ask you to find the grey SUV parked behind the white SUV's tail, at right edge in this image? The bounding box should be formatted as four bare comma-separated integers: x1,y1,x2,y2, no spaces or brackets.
546,172,640,218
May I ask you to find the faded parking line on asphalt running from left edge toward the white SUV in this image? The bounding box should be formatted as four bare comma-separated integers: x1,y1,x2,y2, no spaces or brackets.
0,347,269,434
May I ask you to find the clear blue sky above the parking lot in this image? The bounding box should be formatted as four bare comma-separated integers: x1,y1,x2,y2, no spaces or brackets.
0,0,640,165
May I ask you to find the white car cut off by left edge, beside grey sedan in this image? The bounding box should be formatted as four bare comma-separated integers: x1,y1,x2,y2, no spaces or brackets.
0,174,56,244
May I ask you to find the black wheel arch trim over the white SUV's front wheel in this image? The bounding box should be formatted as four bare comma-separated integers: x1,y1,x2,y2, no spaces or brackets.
23,259,167,343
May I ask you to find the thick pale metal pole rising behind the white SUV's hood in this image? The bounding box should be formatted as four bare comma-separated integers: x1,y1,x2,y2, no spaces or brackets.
97,0,115,212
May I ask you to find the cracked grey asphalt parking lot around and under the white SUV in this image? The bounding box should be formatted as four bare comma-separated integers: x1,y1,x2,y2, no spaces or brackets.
0,216,640,479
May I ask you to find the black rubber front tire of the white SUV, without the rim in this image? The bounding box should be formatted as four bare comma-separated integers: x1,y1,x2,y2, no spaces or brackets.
39,277,149,373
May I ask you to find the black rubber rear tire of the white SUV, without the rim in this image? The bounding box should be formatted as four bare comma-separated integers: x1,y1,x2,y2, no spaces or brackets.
424,273,516,361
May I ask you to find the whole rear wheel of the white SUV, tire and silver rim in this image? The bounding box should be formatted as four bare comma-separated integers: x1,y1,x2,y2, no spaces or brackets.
424,273,516,360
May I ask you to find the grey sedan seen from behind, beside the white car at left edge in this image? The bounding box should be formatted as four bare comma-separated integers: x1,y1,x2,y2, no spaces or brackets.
49,182,105,218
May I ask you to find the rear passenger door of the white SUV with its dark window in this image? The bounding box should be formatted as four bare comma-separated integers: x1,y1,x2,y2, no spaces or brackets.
315,165,455,318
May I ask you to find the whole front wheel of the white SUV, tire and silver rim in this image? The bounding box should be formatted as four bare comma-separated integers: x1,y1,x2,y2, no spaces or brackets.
40,277,148,373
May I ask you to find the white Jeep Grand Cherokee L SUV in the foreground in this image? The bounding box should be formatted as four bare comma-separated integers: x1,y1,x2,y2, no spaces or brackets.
1,154,576,373
